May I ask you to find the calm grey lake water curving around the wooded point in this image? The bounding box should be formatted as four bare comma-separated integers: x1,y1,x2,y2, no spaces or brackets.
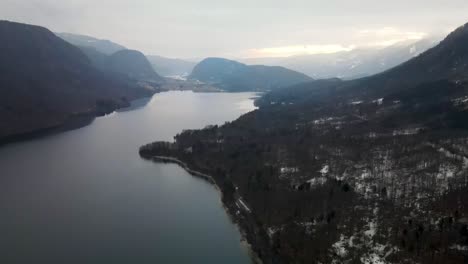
0,92,254,264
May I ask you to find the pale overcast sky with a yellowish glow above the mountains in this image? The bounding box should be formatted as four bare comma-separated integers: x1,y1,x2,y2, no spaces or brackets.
0,0,468,58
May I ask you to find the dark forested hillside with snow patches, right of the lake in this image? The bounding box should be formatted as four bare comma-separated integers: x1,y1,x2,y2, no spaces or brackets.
140,23,468,263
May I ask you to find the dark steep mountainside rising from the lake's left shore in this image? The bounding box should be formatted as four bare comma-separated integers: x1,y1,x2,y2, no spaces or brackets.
0,21,154,141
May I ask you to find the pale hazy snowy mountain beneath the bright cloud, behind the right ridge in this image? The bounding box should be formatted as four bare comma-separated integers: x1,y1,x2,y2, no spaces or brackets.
241,38,439,79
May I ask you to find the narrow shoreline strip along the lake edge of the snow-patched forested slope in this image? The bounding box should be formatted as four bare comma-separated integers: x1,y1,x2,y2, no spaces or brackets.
143,156,263,264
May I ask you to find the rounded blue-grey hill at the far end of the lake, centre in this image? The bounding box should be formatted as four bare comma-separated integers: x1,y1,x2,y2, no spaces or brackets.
189,58,312,92
